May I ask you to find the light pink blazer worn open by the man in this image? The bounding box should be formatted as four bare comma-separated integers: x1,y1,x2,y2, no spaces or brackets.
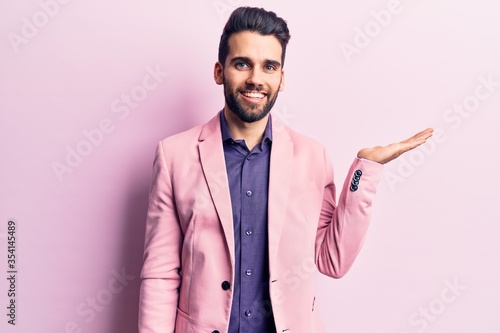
139,110,382,333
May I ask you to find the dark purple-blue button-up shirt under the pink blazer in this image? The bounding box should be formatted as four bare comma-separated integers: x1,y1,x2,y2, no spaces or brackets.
220,112,276,333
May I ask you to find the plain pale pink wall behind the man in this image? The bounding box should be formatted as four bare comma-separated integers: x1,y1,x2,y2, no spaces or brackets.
0,0,500,333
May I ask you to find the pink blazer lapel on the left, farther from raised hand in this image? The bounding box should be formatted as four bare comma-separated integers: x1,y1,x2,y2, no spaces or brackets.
198,112,234,267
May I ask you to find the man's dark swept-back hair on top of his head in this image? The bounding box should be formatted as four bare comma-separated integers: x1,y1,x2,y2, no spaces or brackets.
219,7,290,66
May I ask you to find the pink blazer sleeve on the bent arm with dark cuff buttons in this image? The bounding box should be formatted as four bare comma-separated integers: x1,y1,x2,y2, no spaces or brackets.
315,151,383,278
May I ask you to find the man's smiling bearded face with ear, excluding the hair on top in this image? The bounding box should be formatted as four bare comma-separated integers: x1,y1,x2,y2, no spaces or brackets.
215,31,284,123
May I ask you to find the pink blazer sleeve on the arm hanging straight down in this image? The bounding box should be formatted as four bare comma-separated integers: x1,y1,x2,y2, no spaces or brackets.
139,142,183,333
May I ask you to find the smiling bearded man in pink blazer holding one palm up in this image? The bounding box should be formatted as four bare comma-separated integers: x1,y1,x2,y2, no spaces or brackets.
139,7,432,333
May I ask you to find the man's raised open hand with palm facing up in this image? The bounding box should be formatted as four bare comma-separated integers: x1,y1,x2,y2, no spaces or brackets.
358,128,434,164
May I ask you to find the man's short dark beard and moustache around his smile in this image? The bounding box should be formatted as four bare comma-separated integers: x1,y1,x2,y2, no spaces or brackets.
222,77,278,123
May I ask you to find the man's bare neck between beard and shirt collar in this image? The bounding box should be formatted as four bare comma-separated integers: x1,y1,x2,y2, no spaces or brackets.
223,107,269,150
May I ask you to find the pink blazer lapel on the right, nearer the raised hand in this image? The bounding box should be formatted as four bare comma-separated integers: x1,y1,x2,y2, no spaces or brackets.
268,118,293,272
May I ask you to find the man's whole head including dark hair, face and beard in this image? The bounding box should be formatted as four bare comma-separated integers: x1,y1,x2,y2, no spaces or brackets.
214,7,290,123
